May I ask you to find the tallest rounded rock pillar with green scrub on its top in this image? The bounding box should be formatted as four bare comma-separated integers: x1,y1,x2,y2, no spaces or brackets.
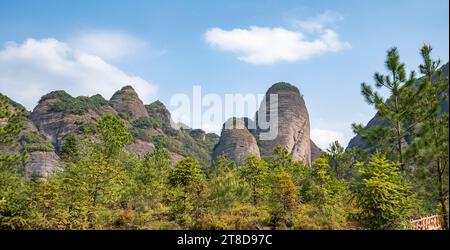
256,82,311,165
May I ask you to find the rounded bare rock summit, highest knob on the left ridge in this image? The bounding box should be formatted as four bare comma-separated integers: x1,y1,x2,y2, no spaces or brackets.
110,86,148,120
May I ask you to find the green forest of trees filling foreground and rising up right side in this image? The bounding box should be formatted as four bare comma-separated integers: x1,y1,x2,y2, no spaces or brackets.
0,45,449,230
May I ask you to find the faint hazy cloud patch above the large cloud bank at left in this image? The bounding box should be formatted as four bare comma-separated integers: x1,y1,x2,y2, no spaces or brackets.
68,30,148,61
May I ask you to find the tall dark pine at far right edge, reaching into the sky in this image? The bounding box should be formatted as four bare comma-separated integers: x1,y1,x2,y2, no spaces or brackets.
409,45,449,229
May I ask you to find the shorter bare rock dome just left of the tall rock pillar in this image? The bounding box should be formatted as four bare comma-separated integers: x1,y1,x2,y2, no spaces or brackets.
212,118,260,163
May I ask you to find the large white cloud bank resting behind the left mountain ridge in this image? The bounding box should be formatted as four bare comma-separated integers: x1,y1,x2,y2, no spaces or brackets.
0,38,157,109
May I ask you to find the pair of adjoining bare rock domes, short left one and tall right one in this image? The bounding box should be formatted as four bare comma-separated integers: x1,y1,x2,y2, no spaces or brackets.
213,82,314,165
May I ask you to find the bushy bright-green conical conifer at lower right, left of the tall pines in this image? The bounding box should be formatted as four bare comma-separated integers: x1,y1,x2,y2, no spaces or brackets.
354,153,415,229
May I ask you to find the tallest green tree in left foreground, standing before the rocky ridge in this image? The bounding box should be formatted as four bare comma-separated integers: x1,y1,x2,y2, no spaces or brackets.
51,114,131,229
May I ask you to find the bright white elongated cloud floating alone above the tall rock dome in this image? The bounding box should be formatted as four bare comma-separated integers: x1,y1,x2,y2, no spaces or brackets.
205,11,350,64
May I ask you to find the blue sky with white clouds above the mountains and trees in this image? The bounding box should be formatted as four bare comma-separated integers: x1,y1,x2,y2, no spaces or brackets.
0,0,449,147
